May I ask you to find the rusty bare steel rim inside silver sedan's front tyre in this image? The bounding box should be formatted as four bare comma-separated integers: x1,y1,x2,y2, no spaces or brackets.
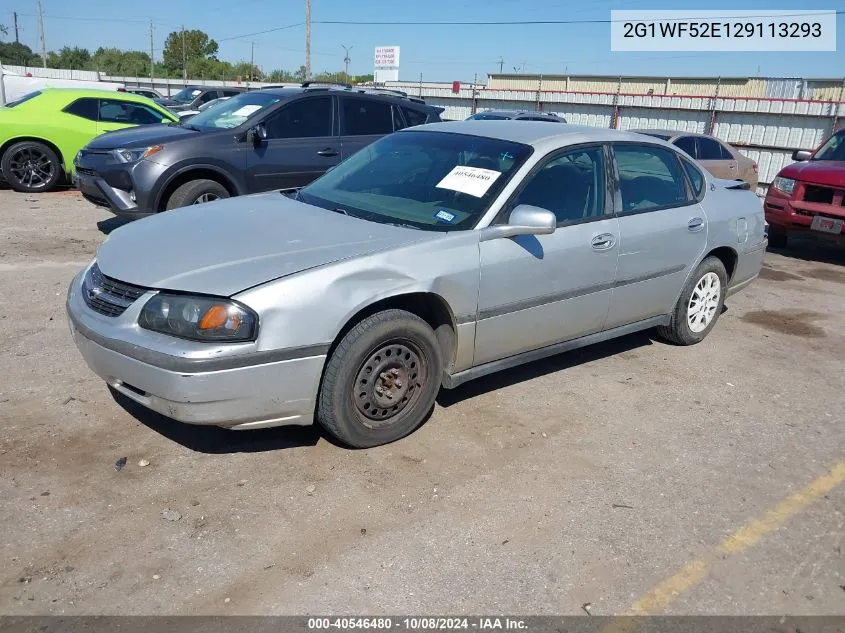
353,341,428,429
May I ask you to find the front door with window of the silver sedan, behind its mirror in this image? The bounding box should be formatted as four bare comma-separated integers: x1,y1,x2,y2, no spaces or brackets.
474,145,619,365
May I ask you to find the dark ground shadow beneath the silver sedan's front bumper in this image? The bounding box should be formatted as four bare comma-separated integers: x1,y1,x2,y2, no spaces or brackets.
109,387,322,455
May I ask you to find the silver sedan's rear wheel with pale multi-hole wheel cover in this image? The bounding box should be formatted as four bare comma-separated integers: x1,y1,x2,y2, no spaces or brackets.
657,257,728,345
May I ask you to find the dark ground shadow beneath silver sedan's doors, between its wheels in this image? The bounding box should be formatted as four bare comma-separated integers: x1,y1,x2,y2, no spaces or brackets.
437,330,662,408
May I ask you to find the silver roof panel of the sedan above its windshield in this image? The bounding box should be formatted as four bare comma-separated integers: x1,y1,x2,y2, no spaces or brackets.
398,119,669,148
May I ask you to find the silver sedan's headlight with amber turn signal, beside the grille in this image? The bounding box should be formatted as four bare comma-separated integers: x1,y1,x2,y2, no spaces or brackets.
138,293,258,343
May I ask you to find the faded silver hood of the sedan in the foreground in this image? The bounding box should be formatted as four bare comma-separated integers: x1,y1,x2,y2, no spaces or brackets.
97,192,440,296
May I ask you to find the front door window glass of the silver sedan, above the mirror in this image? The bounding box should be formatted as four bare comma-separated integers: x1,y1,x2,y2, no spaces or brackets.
512,147,606,226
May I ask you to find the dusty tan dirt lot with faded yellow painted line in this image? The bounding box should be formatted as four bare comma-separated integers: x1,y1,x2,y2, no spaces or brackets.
0,186,845,615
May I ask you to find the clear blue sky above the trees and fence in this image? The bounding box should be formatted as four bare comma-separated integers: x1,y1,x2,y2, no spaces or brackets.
0,0,845,82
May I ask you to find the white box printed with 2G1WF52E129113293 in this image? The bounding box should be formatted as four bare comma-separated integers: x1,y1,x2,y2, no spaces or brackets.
610,9,836,52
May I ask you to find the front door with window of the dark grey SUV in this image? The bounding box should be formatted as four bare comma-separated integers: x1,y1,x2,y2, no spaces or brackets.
247,95,340,192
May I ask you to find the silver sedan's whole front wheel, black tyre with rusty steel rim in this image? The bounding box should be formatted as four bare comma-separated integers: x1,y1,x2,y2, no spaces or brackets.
317,310,443,448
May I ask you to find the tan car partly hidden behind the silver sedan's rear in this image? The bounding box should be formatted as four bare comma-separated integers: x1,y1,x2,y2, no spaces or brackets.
629,130,757,191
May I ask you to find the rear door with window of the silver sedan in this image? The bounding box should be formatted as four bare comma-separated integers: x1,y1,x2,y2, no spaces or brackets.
607,143,707,328
